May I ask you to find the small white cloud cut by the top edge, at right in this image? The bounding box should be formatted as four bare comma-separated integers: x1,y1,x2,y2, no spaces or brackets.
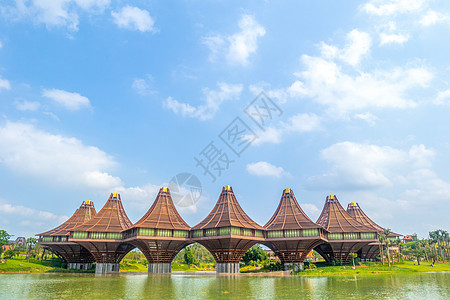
362,0,427,16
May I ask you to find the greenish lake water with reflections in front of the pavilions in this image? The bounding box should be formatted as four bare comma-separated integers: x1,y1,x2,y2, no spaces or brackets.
0,272,450,299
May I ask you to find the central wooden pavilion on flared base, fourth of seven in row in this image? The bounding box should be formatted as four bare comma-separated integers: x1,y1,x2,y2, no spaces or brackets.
191,185,264,273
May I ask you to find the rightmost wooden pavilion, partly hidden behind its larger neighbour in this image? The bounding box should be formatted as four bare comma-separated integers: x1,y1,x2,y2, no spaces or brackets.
347,202,401,260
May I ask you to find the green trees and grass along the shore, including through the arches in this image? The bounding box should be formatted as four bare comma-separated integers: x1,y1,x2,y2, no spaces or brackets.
0,230,450,276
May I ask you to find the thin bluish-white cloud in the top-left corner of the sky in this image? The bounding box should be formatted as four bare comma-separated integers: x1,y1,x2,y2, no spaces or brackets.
3,0,110,31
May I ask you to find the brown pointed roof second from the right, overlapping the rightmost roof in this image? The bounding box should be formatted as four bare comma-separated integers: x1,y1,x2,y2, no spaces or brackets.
316,195,376,233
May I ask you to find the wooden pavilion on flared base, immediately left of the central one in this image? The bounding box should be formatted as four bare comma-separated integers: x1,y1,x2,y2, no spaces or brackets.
124,187,192,273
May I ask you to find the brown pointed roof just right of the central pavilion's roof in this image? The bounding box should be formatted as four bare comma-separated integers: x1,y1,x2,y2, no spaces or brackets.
264,188,321,230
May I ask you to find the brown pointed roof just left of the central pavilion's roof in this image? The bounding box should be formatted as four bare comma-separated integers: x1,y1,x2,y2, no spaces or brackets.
133,187,191,230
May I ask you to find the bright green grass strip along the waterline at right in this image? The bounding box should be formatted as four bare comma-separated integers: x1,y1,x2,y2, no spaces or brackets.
296,261,450,276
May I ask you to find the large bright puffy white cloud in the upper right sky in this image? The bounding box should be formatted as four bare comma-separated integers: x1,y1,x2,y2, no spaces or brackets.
291,55,433,116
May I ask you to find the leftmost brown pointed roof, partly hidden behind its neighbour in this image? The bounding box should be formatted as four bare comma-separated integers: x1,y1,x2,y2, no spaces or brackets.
37,200,97,236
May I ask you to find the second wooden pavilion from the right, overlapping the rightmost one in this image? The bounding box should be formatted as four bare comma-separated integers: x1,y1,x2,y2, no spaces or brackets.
314,195,378,263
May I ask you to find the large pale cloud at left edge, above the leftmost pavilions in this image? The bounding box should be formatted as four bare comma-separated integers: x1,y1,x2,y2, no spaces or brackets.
0,122,122,189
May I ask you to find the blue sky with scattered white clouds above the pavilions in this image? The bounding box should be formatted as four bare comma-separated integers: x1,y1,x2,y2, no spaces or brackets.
0,0,450,236
